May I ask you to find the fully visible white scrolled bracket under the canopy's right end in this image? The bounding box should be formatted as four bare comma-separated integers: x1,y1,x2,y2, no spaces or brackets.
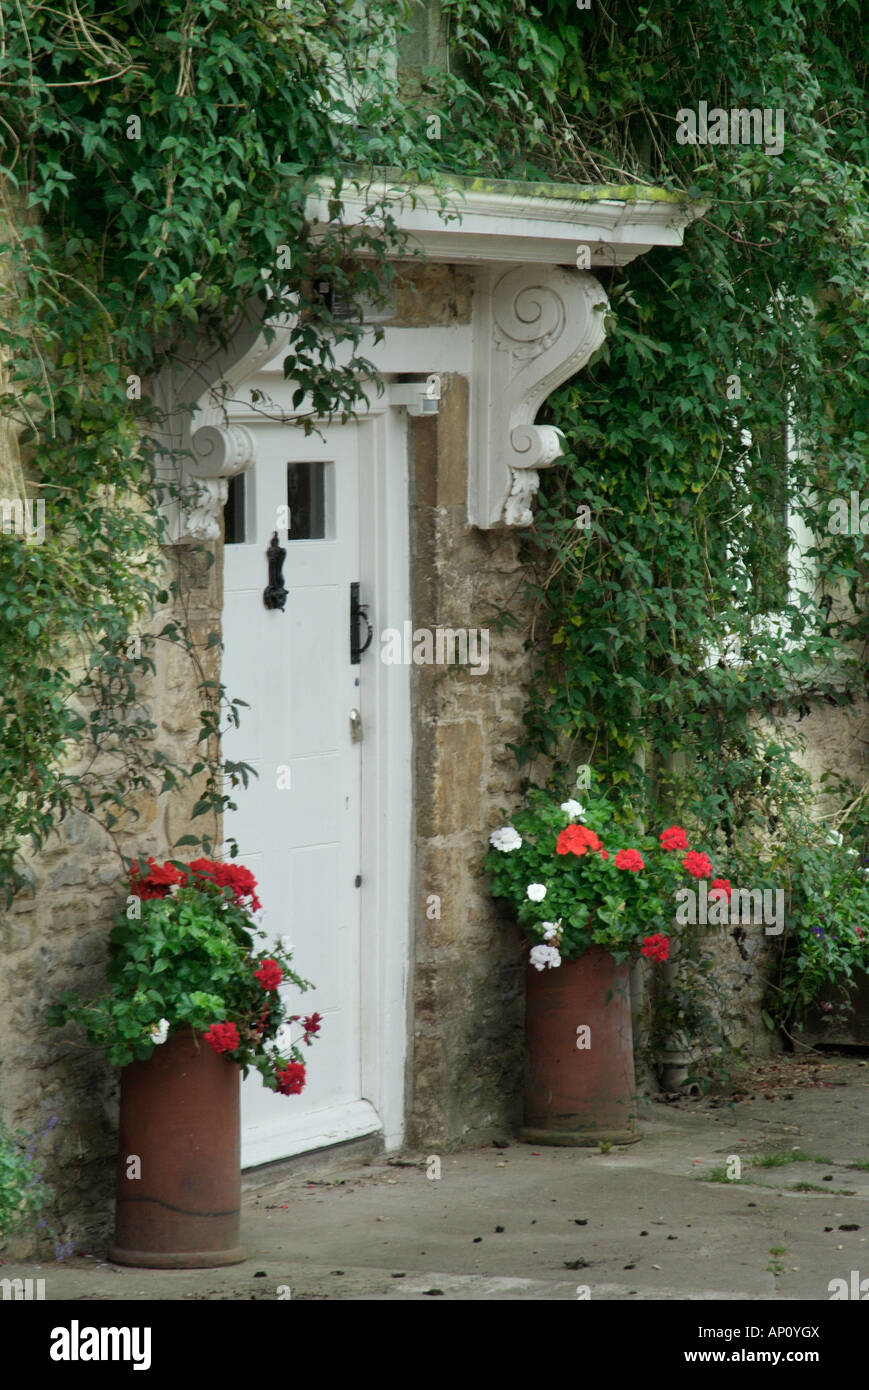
469,265,609,528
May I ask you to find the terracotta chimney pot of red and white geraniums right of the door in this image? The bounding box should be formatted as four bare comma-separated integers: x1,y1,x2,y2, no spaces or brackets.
487,790,730,1145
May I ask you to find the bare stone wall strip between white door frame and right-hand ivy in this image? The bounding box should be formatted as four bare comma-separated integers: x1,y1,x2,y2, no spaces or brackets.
409,361,531,1147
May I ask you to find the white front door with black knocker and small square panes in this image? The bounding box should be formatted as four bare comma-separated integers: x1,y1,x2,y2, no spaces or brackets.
222,424,380,1166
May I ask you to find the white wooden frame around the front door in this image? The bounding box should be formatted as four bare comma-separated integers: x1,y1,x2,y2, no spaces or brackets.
219,386,413,1166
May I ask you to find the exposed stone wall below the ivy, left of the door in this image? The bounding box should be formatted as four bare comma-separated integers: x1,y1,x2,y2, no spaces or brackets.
0,536,221,1257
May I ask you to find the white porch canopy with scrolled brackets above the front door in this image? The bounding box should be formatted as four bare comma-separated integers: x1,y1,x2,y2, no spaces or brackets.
163,178,704,538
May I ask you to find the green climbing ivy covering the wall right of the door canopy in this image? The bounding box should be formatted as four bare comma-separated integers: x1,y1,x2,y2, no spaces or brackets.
405,0,869,1027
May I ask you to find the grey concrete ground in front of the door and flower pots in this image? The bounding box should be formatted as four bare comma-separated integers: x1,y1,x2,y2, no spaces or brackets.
6,1056,869,1301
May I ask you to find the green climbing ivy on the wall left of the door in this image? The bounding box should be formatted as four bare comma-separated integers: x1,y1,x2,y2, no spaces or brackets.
0,0,432,899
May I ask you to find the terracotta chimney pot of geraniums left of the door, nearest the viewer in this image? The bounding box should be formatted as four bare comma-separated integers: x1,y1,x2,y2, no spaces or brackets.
49,859,321,1268
